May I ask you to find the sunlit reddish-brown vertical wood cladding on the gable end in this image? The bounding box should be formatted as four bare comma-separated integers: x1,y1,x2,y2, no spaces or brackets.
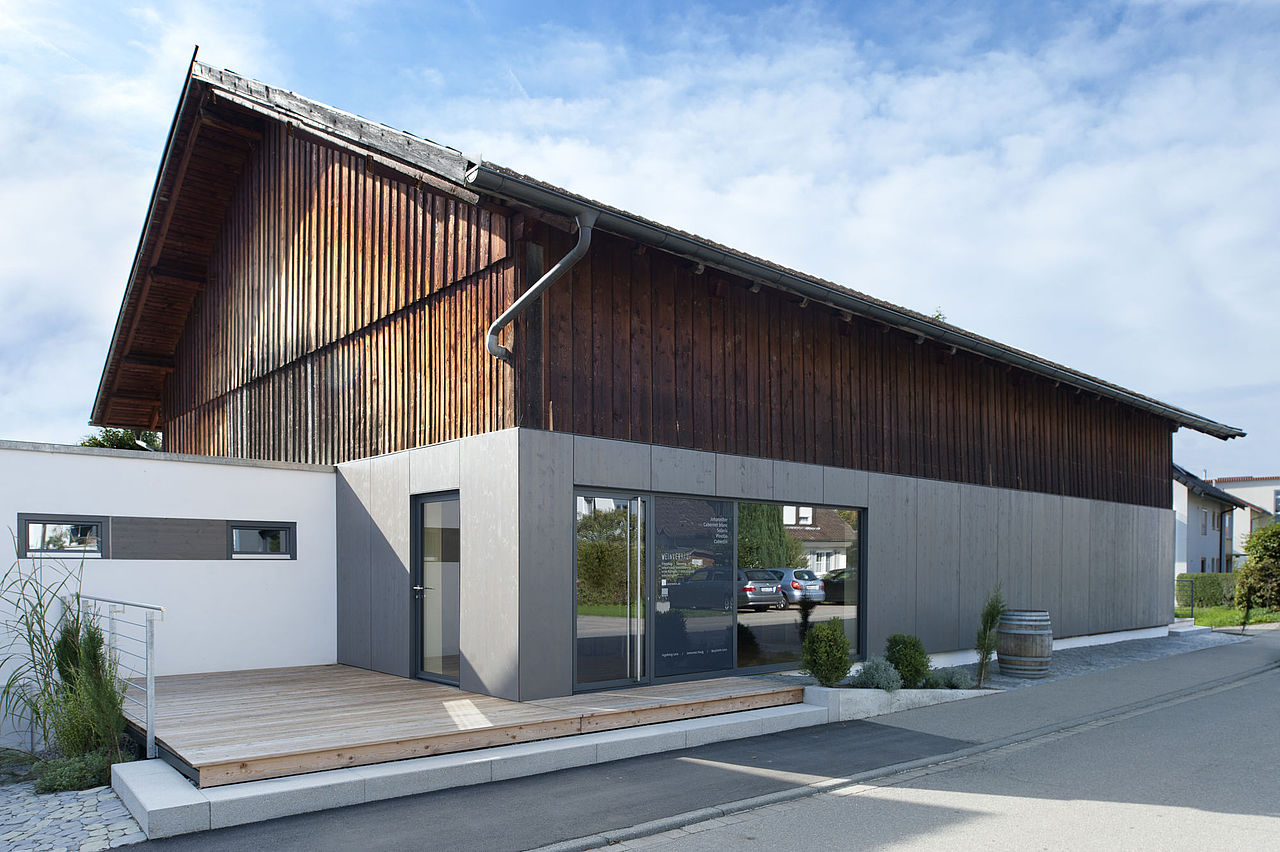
163,125,516,463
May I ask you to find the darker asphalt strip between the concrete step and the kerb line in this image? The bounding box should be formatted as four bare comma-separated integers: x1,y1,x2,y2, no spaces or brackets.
142,722,970,852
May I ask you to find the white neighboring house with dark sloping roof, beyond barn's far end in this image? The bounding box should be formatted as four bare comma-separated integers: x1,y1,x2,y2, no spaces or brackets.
1174,464,1247,576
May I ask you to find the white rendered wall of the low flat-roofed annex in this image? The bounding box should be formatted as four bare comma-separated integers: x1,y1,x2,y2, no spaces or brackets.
0,441,337,674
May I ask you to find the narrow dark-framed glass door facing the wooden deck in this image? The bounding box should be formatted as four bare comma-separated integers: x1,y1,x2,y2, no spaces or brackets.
412,495,461,684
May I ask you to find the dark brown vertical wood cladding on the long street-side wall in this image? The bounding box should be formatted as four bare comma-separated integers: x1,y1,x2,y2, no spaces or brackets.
517,223,1172,508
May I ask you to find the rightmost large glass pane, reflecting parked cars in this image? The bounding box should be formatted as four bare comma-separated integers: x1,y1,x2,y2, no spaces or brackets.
737,503,861,668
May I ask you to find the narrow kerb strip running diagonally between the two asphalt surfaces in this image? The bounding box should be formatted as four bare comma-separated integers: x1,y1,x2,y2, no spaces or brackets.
530,661,1280,852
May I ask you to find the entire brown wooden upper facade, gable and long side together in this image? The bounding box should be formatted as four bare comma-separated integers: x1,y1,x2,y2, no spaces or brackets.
115,74,1172,508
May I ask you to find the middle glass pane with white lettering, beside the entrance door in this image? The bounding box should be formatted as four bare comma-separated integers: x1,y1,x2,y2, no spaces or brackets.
654,496,737,677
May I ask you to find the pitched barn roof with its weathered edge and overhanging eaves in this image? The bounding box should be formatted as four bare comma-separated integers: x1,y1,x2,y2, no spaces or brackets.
91,59,1244,439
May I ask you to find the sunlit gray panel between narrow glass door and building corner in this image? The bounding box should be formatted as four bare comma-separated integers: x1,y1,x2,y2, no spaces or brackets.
458,429,519,700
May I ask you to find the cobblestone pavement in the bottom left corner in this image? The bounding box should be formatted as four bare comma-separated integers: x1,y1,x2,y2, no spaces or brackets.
0,782,147,852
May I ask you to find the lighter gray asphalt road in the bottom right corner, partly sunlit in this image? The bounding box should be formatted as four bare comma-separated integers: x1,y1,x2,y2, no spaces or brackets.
609,669,1280,852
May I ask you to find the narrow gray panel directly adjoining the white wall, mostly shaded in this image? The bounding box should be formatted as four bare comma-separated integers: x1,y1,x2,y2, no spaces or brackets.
334,461,372,669
